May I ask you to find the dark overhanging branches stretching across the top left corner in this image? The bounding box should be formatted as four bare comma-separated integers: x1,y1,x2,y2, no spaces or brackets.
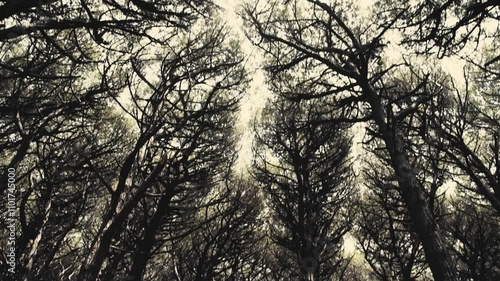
0,0,214,41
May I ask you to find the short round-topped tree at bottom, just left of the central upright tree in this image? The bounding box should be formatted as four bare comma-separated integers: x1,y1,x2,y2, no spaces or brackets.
166,178,262,280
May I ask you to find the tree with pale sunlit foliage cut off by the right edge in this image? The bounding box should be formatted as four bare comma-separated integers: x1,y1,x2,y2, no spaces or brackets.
416,62,500,214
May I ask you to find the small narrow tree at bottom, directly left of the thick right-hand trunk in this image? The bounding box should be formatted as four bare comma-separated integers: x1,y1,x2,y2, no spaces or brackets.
355,163,428,281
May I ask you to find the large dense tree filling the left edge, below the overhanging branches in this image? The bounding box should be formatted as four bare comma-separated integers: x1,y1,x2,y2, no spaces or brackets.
0,25,133,280
